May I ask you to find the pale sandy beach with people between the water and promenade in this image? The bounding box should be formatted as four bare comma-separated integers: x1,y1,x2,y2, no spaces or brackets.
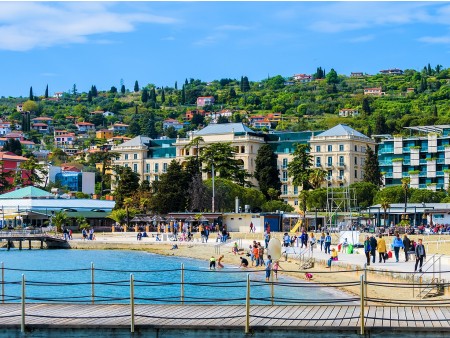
57,233,449,300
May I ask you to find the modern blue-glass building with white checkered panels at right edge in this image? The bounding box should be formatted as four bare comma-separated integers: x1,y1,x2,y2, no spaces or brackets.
378,125,450,191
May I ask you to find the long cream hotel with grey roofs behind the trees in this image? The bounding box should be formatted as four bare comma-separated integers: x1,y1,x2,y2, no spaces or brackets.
112,123,375,209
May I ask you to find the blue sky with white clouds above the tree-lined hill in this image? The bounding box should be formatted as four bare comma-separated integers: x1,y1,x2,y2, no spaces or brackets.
0,1,450,96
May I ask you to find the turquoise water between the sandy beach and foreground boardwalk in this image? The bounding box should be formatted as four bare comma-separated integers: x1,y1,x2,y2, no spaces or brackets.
0,250,346,304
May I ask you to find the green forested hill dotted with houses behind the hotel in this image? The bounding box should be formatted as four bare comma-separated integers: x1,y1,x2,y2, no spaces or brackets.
0,65,450,137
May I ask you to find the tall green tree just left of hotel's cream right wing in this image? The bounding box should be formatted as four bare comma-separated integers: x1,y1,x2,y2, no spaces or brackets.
288,144,312,190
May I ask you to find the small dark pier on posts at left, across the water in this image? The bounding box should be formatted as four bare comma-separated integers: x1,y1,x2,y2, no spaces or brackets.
0,232,70,250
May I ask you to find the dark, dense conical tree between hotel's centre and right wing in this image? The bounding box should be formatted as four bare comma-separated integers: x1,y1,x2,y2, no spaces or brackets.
254,144,281,198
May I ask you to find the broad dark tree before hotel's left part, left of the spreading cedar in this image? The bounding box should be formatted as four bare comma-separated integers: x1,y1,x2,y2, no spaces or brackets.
152,160,190,214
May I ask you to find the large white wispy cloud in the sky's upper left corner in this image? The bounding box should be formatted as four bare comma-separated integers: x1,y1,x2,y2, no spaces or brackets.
0,2,176,51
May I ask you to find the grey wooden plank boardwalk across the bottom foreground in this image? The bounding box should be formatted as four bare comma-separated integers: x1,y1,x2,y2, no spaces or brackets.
0,303,450,336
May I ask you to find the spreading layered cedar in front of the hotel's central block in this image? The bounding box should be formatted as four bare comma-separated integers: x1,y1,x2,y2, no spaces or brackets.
200,142,250,186
